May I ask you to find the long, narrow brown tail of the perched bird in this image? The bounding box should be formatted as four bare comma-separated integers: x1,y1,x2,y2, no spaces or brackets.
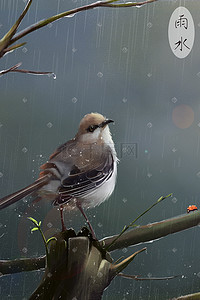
0,174,51,210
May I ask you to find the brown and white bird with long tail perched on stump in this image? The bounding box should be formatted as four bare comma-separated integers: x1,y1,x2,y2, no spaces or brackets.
0,113,118,239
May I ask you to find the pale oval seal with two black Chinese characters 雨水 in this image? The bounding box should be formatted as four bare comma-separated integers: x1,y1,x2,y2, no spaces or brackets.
168,6,195,58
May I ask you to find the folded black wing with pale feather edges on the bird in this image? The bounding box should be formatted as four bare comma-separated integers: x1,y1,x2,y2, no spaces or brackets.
54,149,114,205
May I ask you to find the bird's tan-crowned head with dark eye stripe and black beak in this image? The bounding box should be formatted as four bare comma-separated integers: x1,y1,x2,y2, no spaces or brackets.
76,113,114,142
